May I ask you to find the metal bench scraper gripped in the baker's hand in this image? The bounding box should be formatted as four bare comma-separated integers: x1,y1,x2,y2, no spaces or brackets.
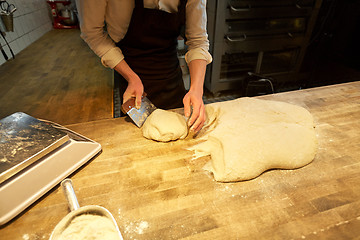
121,93,156,128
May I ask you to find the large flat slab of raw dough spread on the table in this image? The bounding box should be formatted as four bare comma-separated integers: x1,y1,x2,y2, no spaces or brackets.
190,98,317,182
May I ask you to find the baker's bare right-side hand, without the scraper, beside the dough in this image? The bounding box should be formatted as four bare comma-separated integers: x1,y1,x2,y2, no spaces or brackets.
183,90,206,133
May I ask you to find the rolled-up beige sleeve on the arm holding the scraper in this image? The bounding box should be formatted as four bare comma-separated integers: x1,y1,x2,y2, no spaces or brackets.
76,0,124,68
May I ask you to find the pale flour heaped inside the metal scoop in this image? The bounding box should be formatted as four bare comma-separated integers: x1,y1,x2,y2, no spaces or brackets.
57,214,120,240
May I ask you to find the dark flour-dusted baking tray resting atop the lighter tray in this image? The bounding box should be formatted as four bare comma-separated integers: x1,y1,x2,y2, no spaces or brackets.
0,112,70,183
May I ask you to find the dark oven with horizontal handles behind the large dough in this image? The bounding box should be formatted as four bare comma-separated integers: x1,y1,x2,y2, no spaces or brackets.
205,0,321,93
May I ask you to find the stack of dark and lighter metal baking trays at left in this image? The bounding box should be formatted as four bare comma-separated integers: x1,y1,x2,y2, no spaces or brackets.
0,113,101,225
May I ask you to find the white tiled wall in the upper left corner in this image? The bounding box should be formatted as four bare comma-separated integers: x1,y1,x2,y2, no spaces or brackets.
0,0,52,65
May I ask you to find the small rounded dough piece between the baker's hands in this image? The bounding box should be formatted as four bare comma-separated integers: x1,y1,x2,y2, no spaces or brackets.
142,109,188,142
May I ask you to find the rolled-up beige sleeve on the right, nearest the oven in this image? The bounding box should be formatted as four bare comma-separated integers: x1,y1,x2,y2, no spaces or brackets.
185,0,212,64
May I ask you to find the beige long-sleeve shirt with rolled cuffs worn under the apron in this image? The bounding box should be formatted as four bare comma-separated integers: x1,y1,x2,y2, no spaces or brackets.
76,0,212,68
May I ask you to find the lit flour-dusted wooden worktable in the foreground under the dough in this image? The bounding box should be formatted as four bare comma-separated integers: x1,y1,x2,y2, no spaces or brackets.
0,82,360,240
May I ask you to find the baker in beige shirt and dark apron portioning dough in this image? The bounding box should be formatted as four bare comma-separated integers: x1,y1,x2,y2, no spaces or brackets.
77,0,212,132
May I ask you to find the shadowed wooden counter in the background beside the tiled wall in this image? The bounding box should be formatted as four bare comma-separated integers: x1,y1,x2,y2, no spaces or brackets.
0,29,113,124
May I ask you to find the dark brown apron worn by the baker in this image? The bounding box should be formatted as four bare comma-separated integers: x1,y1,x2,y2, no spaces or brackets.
114,0,186,109
